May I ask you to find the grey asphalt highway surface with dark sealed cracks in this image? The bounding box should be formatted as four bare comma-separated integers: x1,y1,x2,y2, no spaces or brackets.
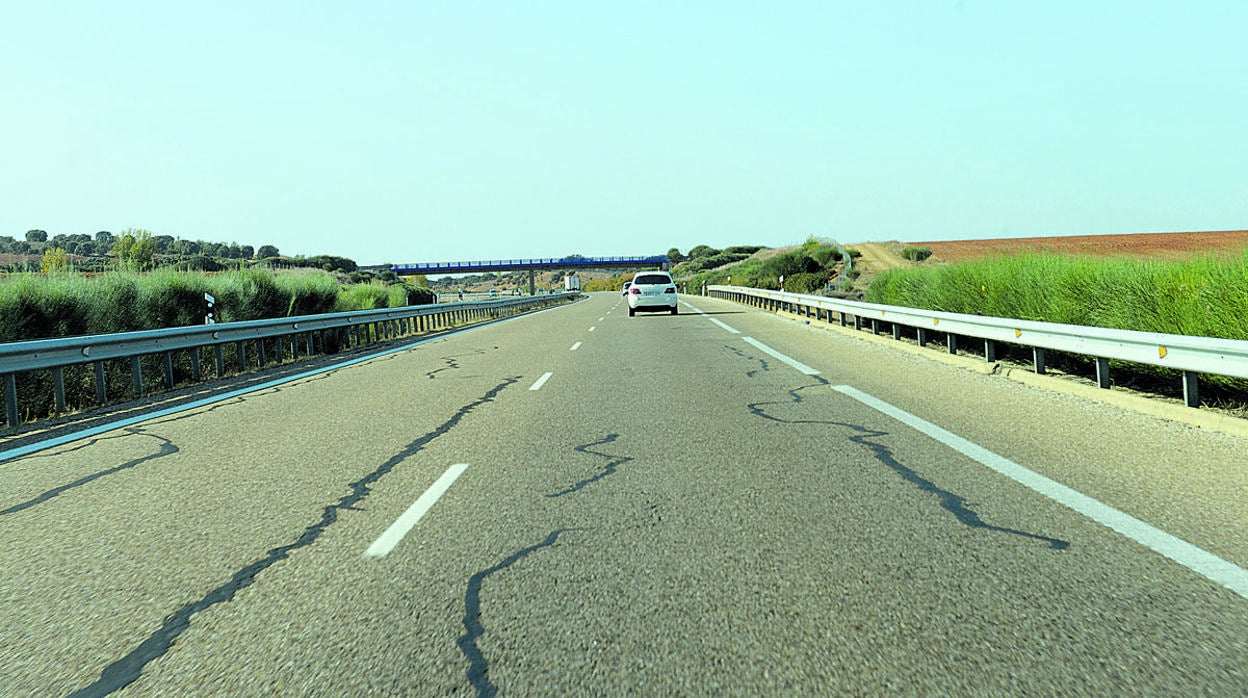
0,295,1248,696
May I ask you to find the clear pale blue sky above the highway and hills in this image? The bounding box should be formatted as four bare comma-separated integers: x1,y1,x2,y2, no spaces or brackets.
0,0,1248,263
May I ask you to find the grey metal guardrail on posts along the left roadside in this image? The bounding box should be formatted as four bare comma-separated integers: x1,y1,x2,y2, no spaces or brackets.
0,293,579,427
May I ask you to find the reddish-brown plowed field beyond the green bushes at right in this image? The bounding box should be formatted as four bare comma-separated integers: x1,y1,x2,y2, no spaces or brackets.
909,230,1248,262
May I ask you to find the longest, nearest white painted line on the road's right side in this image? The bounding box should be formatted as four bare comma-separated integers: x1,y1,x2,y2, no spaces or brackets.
832,386,1248,599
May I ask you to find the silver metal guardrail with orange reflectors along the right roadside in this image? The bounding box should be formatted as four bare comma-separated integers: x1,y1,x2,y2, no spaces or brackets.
706,286,1248,407
